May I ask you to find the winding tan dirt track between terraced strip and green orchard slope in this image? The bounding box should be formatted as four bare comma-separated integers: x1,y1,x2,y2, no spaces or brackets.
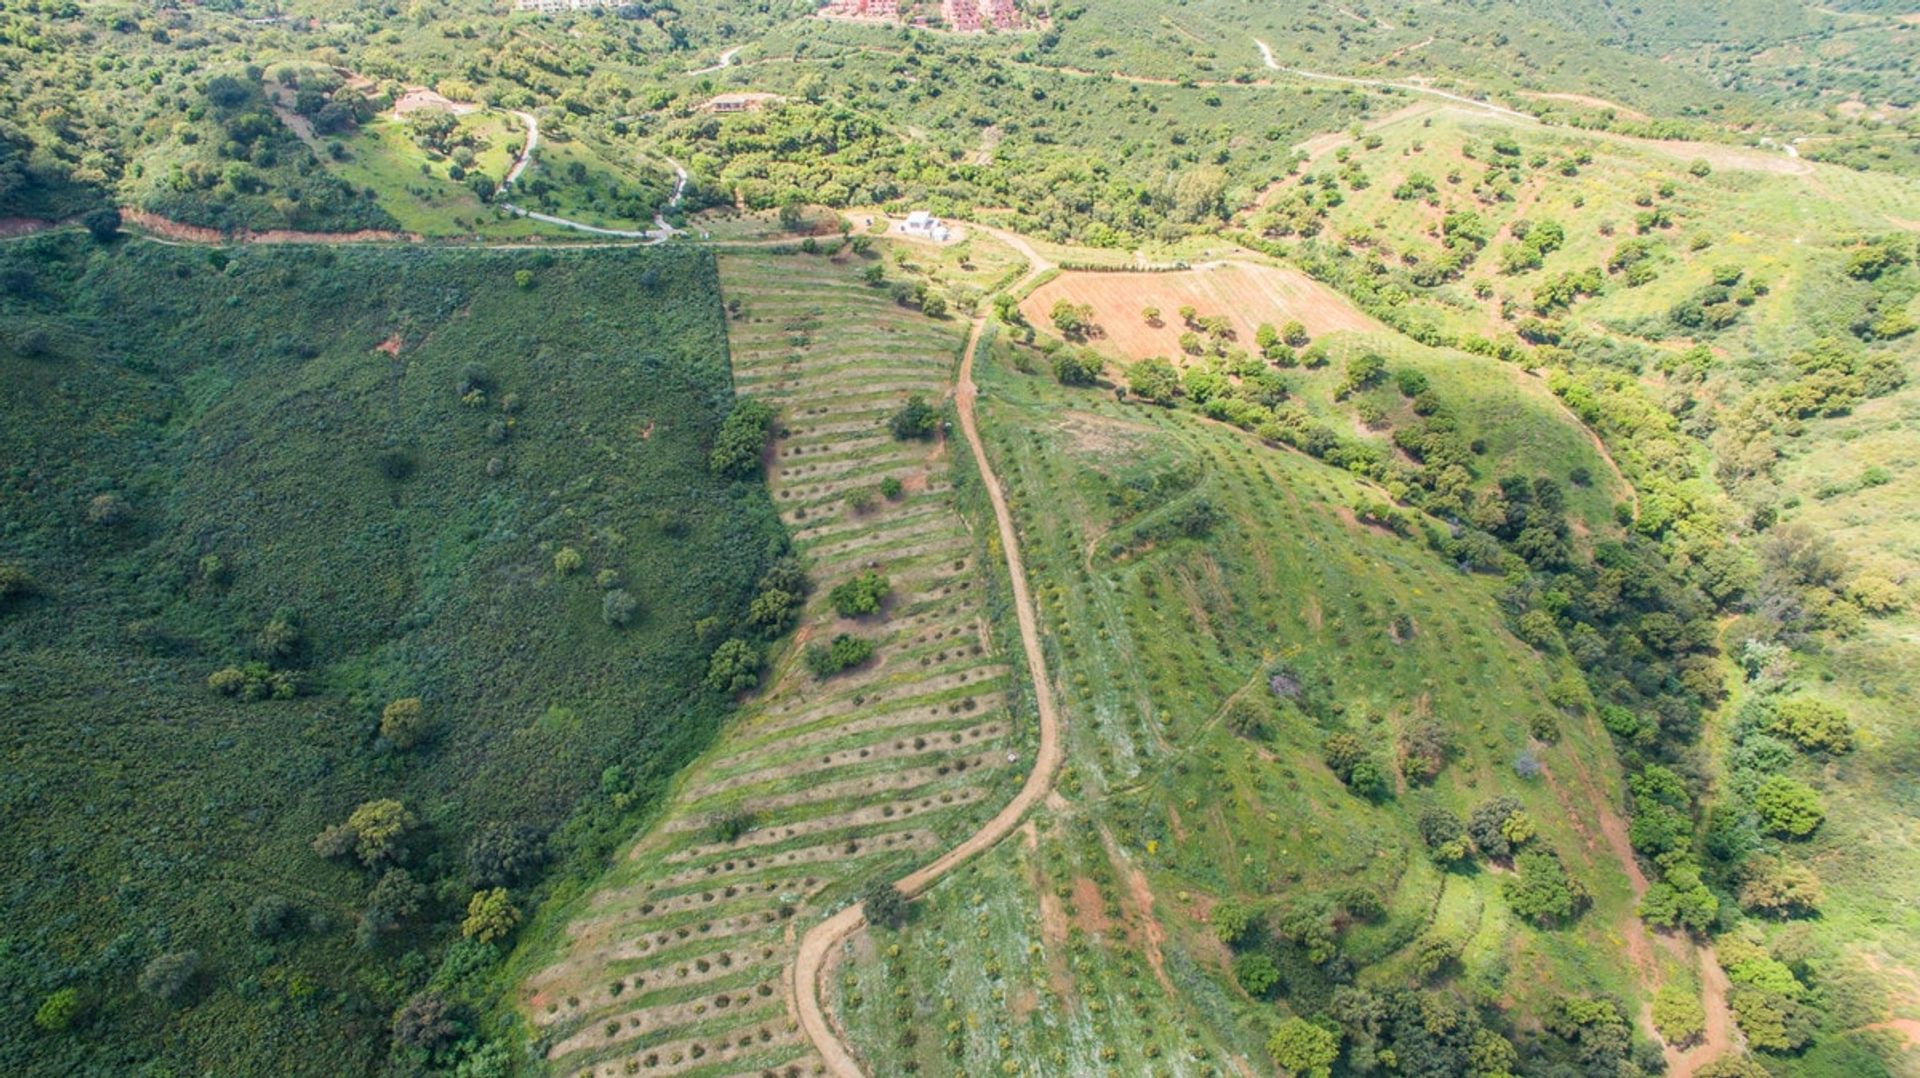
787,239,1062,1078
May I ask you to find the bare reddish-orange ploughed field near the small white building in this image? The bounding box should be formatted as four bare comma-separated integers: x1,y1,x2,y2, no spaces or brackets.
1020,261,1379,359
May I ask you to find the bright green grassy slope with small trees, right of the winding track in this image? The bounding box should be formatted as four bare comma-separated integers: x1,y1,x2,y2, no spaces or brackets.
841,322,1682,1074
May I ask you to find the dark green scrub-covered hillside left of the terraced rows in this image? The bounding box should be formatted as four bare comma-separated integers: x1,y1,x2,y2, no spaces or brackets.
0,233,783,1074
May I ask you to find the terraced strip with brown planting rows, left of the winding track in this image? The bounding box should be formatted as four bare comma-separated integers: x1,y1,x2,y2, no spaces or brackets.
520,254,1029,1076
